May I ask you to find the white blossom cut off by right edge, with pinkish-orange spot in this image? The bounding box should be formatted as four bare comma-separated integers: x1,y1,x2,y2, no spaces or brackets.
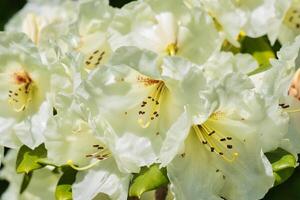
255,37,300,155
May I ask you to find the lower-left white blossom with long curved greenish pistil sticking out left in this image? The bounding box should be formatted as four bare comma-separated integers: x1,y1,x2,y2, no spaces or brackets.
45,96,131,200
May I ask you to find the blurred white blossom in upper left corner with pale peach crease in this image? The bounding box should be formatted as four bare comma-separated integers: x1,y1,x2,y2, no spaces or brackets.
5,0,76,44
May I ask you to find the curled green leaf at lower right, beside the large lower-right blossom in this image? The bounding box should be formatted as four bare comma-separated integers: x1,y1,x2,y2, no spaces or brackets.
266,149,297,186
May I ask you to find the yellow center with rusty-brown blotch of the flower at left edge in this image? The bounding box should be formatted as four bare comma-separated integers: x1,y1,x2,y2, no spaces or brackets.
8,71,35,112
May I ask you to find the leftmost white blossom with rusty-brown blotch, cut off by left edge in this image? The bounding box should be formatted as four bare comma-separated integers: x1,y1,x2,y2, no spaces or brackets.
0,33,52,147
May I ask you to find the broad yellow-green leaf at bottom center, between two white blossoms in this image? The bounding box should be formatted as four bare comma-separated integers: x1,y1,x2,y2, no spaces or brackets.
129,164,169,198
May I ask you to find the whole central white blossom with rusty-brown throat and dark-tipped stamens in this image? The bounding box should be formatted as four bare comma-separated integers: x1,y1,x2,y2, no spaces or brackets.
78,47,219,172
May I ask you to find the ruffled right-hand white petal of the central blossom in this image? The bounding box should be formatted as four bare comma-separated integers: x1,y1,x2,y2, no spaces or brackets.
162,57,217,124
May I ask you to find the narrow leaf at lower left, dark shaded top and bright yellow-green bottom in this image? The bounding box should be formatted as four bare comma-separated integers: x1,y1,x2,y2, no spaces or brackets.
55,166,77,200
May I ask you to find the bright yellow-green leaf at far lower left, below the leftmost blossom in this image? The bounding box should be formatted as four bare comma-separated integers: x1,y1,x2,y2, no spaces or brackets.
16,144,47,174
